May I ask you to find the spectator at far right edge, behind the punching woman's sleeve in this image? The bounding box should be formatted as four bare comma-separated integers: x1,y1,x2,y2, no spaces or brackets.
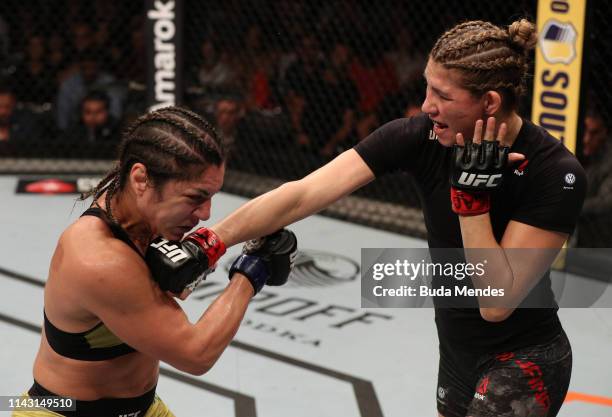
576,106,612,248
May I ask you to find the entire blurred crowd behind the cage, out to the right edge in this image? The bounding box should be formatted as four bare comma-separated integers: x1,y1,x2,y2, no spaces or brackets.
0,0,612,246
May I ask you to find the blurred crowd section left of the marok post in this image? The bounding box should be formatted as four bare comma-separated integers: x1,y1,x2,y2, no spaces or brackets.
0,0,145,157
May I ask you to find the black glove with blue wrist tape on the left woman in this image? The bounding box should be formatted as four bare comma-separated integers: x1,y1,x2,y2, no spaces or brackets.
229,229,297,294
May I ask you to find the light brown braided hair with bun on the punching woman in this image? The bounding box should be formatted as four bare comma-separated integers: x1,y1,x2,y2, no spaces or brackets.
429,19,537,109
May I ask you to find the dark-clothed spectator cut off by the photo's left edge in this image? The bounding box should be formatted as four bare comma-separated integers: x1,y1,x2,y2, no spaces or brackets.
0,85,43,142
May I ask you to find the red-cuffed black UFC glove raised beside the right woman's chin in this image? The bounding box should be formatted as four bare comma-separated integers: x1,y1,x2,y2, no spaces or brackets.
450,141,510,216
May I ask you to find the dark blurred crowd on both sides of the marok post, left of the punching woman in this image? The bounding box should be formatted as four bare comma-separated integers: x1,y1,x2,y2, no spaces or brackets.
0,0,426,158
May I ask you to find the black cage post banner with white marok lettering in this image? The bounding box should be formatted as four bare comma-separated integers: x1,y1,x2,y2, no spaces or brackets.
145,0,184,110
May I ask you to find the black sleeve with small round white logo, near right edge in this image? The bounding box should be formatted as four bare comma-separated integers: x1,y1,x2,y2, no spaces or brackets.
512,152,587,233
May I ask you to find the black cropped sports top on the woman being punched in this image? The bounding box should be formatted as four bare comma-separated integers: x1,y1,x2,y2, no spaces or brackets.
44,207,140,361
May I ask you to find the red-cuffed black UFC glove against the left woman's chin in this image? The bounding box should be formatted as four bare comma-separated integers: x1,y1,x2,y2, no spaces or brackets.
145,227,226,295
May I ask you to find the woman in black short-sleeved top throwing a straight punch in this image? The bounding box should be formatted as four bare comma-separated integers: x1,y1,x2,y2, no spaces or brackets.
212,19,585,417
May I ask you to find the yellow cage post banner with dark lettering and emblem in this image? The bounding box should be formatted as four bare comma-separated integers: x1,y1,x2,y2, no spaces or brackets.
531,0,586,152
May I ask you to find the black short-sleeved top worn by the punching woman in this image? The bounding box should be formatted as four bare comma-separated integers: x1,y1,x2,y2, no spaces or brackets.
355,114,586,353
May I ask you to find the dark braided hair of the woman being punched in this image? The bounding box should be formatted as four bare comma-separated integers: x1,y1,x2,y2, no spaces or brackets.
81,106,225,221
